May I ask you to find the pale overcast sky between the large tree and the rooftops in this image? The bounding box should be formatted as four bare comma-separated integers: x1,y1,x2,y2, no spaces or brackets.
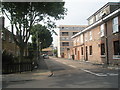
53,0,120,46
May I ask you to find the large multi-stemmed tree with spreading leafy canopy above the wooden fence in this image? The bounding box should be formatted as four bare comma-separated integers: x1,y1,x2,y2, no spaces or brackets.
2,2,67,60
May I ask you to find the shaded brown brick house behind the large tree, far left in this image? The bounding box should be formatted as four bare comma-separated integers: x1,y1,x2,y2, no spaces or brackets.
0,17,28,56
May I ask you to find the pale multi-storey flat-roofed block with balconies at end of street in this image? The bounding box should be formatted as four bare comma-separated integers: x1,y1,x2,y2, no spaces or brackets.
58,25,86,58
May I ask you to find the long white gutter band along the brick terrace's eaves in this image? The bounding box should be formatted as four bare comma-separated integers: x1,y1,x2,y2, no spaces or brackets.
71,9,120,38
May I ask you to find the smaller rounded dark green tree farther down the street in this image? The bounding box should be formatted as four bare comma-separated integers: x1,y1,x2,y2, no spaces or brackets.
31,24,53,49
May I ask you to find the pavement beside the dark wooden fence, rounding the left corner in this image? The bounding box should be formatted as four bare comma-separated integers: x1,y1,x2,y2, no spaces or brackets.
0,59,51,82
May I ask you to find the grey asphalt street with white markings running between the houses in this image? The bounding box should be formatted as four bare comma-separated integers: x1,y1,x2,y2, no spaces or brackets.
4,57,118,88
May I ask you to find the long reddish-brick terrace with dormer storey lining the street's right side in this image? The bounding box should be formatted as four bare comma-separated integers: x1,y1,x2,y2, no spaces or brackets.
71,2,120,64
